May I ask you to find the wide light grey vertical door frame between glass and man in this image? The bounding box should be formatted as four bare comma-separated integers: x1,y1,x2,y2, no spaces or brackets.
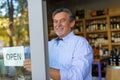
28,0,50,80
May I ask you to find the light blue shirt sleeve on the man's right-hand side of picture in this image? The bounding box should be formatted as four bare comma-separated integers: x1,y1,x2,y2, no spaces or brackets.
60,39,93,80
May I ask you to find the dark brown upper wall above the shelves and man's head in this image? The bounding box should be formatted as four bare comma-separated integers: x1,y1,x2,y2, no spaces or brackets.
47,0,120,15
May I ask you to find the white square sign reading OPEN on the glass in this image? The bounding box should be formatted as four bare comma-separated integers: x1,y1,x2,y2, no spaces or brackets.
3,46,25,66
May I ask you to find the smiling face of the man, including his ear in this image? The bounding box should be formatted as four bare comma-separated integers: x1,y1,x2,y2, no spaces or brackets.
53,12,75,38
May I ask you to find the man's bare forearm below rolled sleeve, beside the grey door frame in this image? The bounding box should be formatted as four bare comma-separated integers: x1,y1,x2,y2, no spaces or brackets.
50,68,60,80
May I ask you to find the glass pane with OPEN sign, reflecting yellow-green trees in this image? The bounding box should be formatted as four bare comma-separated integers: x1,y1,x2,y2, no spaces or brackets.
0,0,32,80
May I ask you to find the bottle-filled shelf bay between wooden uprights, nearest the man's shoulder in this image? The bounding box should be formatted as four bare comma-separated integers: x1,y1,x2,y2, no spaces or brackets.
85,16,108,46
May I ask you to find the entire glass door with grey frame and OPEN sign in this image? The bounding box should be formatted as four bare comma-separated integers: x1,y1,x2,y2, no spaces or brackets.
0,0,49,80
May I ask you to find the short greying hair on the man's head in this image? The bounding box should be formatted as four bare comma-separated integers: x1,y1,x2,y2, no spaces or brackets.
52,8,75,22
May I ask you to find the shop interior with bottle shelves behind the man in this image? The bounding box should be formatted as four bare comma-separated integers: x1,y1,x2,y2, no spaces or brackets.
47,0,120,80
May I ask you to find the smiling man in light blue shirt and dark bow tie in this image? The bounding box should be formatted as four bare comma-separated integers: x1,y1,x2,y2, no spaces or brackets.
25,8,93,80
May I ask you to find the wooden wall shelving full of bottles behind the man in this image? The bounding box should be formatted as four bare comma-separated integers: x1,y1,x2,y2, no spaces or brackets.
75,9,120,55
